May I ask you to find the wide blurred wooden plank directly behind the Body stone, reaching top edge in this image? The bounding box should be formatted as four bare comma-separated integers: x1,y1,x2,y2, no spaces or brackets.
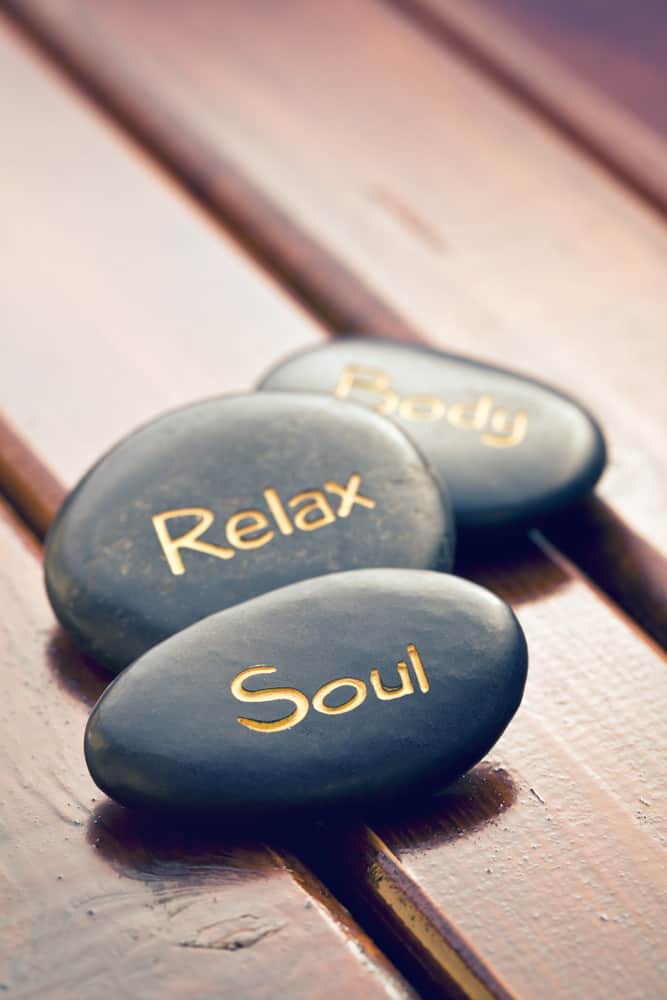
10,0,667,643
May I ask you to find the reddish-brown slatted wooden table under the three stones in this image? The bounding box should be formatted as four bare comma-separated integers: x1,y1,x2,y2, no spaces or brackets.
0,0,667,1000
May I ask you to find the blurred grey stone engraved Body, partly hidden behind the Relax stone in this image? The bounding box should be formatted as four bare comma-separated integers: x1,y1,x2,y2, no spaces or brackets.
260,337,606,529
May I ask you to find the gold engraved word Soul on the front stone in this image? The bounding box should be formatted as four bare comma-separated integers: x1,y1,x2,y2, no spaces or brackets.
230,643,431,733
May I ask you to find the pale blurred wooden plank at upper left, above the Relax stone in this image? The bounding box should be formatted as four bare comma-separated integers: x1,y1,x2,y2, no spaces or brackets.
0,10,324,484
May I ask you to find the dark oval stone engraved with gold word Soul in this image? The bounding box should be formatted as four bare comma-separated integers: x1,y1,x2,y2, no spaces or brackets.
85,569,527,820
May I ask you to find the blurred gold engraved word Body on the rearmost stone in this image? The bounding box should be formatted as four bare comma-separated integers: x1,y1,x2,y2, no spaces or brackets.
334,365,528,448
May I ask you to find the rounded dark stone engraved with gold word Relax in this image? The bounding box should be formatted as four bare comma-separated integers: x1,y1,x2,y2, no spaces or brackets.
45,393,454,670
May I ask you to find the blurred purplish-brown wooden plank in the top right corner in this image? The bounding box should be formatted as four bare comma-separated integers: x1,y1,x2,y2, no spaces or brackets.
389,0,667,209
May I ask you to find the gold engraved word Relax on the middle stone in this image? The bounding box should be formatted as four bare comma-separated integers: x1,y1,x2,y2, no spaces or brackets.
152,472,375,576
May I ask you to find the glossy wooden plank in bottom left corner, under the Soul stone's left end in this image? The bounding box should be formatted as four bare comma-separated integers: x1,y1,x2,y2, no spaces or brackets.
0,505,413,1000
